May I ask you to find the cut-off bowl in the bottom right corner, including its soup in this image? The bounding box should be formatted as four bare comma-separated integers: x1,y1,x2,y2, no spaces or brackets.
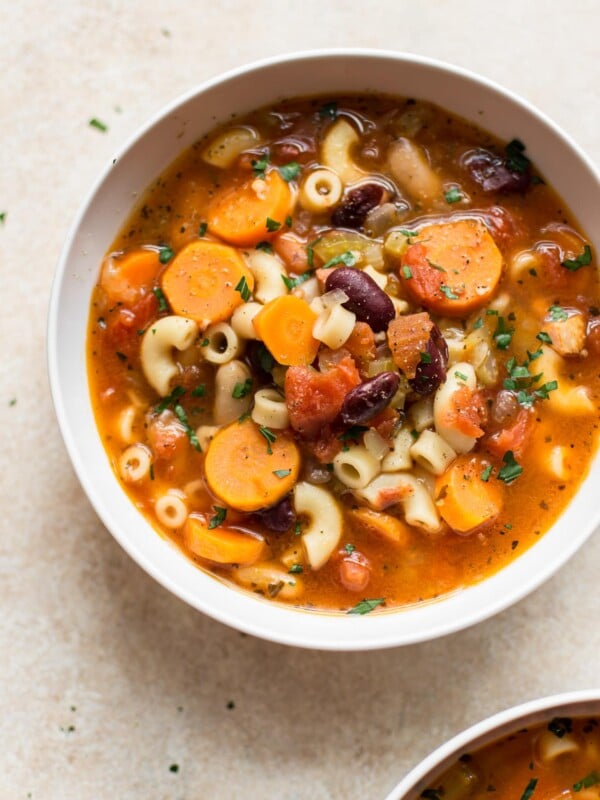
387,691,600,800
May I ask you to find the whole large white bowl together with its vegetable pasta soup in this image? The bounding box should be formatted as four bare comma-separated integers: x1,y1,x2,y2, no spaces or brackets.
50,53,600,648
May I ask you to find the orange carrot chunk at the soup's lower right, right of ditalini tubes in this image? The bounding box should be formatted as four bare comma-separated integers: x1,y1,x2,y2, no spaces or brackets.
435,456,503,533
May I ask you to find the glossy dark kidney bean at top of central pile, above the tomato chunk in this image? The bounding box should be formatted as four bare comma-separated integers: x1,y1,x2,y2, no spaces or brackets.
325,267,396,333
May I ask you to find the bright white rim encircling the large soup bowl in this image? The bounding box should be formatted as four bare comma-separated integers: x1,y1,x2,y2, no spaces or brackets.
47,48,600,651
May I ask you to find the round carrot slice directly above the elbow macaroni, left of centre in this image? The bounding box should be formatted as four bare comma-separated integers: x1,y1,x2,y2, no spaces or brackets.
161,241,254,327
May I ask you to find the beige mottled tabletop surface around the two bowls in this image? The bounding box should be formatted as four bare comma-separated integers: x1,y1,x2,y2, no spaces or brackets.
0,0,600,800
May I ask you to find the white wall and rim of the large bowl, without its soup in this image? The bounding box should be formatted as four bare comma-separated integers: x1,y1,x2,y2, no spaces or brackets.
48,50,600,650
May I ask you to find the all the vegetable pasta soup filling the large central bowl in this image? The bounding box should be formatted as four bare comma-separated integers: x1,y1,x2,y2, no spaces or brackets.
88,96,600,612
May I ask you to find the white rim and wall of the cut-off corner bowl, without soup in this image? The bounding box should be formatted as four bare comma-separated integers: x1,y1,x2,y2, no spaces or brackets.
385,689,600,800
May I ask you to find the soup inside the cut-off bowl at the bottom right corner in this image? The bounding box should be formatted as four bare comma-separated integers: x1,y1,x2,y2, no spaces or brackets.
421,717,600,800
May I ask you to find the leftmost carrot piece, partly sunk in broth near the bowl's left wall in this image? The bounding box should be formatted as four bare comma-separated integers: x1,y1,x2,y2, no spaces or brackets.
100,248,160,305
